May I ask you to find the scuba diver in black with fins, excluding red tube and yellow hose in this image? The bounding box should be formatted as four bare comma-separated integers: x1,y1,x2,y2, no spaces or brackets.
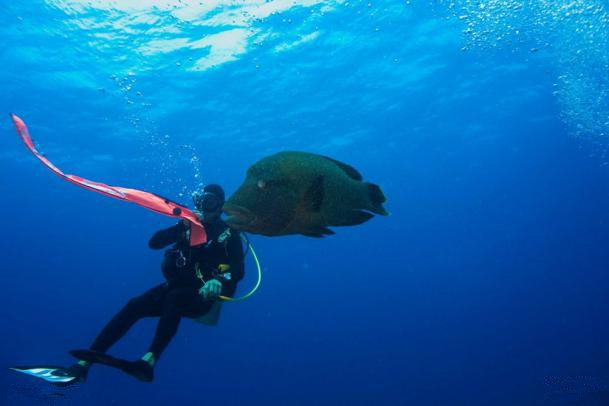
44,184,244,386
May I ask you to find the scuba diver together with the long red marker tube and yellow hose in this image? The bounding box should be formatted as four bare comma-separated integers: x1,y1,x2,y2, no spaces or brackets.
9,113,255,386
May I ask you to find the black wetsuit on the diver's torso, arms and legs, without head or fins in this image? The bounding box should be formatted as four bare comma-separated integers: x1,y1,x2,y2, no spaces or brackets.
91,220,243,359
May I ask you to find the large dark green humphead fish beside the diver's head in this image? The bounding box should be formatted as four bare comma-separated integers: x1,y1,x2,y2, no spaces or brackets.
223,151,388,237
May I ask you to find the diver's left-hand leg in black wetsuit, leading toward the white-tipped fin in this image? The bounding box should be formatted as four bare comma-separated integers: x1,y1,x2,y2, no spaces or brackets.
91,283,169,352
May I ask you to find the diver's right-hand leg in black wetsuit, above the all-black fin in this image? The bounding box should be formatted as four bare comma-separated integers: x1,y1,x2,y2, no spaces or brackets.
146,288,213,365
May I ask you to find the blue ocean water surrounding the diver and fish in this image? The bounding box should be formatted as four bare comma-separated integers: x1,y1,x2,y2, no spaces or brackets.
0,0,609,406
